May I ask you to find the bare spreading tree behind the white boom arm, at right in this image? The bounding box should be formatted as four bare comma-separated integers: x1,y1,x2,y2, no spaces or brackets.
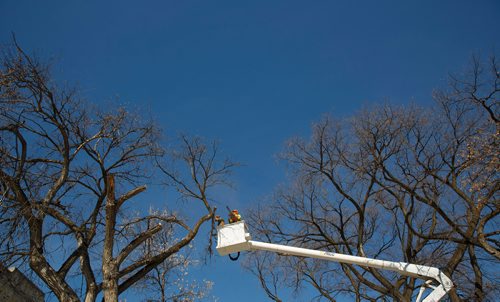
251,55,500,301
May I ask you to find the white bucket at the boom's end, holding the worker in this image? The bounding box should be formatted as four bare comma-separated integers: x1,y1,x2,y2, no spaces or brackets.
216,221,251,256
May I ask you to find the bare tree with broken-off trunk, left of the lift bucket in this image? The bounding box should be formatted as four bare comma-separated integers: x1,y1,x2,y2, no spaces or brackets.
0,40,234,301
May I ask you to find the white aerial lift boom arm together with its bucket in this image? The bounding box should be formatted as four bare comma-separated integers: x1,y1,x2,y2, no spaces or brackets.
217,221,453,302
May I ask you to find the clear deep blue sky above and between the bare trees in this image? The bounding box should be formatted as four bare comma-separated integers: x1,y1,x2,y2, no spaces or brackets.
0,0,500,302
